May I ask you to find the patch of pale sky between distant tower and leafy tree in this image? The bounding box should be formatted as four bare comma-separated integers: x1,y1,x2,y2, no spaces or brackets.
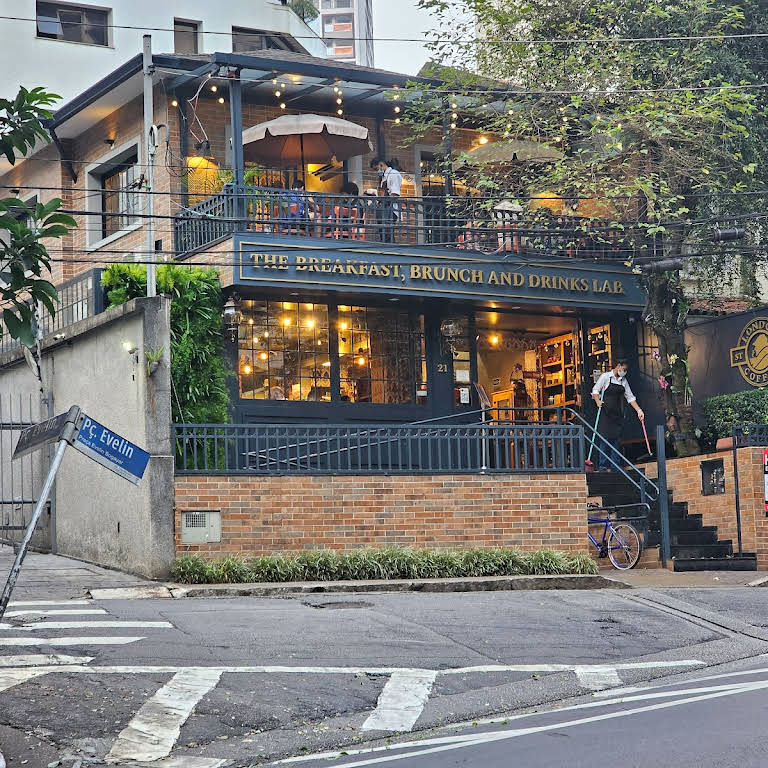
373,0,432,75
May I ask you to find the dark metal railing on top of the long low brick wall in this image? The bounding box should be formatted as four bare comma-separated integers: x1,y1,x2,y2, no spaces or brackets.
174,424,584,475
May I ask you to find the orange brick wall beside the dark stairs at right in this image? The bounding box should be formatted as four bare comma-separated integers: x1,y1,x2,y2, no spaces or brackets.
644,448,768,569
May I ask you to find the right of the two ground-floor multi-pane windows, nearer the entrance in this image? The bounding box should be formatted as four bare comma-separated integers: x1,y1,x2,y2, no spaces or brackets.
338,305,427,405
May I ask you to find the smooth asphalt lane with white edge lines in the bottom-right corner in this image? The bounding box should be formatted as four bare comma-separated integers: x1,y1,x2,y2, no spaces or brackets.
286,659,768,768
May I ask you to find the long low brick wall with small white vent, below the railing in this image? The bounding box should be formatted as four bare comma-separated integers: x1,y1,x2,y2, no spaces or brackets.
176,474,587,557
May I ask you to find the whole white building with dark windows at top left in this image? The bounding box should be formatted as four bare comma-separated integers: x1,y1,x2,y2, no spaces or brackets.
0,0,324,102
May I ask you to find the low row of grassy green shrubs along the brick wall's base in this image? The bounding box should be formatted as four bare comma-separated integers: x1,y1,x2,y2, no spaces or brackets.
171,547,598,584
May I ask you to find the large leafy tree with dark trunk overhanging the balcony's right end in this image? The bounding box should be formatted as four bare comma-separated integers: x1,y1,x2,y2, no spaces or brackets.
412,0,768,455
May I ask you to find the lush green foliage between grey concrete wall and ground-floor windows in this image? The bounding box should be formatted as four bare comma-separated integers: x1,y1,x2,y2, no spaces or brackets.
102,264,230,424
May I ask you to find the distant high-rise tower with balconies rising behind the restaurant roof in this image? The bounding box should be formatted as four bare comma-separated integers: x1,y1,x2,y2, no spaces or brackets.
314,0,373,67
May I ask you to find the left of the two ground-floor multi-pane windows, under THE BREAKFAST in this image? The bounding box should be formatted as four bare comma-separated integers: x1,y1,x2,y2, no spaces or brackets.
238,301,331,401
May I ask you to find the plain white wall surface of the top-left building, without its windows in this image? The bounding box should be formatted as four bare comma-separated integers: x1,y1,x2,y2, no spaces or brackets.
0,0,326,101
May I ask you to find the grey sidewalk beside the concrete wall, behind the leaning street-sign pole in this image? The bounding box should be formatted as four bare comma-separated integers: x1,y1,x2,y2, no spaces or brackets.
0,544,154,604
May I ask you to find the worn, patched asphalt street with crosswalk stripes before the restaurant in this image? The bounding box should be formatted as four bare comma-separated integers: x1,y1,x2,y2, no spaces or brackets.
0,588,768,768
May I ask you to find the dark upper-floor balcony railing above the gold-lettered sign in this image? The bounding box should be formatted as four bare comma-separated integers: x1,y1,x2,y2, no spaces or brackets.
175,185,660,261
